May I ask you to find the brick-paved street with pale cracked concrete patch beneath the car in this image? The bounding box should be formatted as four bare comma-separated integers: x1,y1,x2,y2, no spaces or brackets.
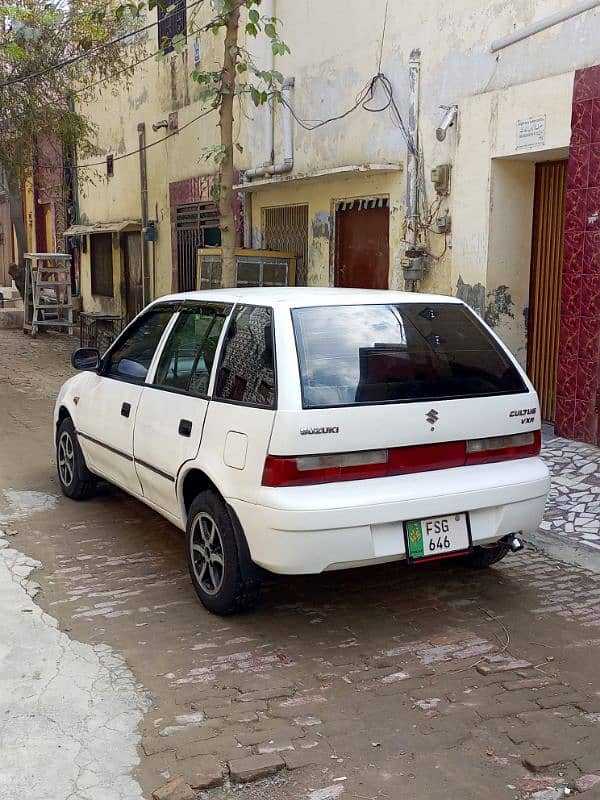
0,326,600,800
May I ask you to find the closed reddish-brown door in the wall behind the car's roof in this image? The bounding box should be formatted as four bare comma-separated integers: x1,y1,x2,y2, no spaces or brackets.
335,199,390,289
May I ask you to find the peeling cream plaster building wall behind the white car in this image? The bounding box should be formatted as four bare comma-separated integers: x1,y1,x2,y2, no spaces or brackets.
76,0,600,351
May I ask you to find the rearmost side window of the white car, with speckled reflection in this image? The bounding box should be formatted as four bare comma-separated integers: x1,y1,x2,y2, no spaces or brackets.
214,306,275,408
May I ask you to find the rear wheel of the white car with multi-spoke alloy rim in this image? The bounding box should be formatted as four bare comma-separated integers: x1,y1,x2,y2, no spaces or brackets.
186,489,259,616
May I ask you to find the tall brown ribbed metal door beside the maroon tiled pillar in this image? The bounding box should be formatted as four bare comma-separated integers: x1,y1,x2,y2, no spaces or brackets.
527,161,567,422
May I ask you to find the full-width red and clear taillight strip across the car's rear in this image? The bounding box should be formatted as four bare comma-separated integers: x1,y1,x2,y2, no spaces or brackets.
262,431,541,486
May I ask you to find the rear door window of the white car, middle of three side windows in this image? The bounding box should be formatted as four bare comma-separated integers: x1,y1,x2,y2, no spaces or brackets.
154,303,231,396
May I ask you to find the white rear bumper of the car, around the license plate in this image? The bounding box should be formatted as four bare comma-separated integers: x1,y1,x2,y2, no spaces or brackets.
227,458,550,574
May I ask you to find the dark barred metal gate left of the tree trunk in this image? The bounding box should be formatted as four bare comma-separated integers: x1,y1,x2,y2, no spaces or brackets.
175,203,221,292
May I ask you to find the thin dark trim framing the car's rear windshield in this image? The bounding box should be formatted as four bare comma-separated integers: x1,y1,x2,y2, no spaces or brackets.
289,302,531,411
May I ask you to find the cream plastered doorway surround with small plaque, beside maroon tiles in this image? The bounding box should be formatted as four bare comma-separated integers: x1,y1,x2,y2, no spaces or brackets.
451,73,573,366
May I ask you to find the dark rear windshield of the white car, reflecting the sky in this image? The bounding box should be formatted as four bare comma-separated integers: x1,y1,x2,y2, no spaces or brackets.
292,303,527,408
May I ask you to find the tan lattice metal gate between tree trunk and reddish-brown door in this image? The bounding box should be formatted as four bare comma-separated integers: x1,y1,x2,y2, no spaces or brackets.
263,205,308,286
